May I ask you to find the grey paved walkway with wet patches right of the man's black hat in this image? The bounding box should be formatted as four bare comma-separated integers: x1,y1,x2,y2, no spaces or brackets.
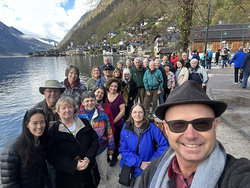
207,67,250,141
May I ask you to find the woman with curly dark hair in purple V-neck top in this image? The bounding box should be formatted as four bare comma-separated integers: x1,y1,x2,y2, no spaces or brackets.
106,78,125,167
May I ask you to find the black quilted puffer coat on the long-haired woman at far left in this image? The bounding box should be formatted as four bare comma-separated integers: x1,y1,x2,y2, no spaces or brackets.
1,139,49,188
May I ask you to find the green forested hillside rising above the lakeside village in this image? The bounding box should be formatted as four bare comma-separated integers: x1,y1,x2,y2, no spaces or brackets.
59,0,250,49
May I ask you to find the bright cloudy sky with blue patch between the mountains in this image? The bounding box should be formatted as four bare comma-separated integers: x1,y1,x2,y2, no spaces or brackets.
0,0,98,42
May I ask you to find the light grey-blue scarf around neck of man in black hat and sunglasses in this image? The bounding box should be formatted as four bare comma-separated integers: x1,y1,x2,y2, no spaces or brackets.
149,141,226,188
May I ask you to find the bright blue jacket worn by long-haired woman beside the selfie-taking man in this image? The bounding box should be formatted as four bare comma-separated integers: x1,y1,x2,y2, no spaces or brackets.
119,123,168,177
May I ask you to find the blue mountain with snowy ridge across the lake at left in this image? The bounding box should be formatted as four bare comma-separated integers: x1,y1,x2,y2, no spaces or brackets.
0,22,54,56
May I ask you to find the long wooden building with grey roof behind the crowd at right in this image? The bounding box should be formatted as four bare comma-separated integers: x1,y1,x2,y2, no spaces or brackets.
190,24,250,52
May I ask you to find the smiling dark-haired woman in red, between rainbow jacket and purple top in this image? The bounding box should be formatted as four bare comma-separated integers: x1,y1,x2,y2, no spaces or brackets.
93,85,115,135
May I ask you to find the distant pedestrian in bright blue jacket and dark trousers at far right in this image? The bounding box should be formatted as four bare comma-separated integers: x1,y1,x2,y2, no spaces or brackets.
229,47,246,84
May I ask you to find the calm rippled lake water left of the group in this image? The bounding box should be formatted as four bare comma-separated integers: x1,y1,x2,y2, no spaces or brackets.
0,56,125,152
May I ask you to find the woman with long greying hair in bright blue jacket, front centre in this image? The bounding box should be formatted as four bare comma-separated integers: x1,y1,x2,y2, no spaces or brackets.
119,103,168,187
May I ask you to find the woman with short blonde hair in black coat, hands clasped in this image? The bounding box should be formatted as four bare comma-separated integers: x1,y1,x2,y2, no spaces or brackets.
48,97,99,188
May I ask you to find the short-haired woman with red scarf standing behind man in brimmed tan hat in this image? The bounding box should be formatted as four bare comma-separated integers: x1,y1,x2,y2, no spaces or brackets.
60,65,87,107
